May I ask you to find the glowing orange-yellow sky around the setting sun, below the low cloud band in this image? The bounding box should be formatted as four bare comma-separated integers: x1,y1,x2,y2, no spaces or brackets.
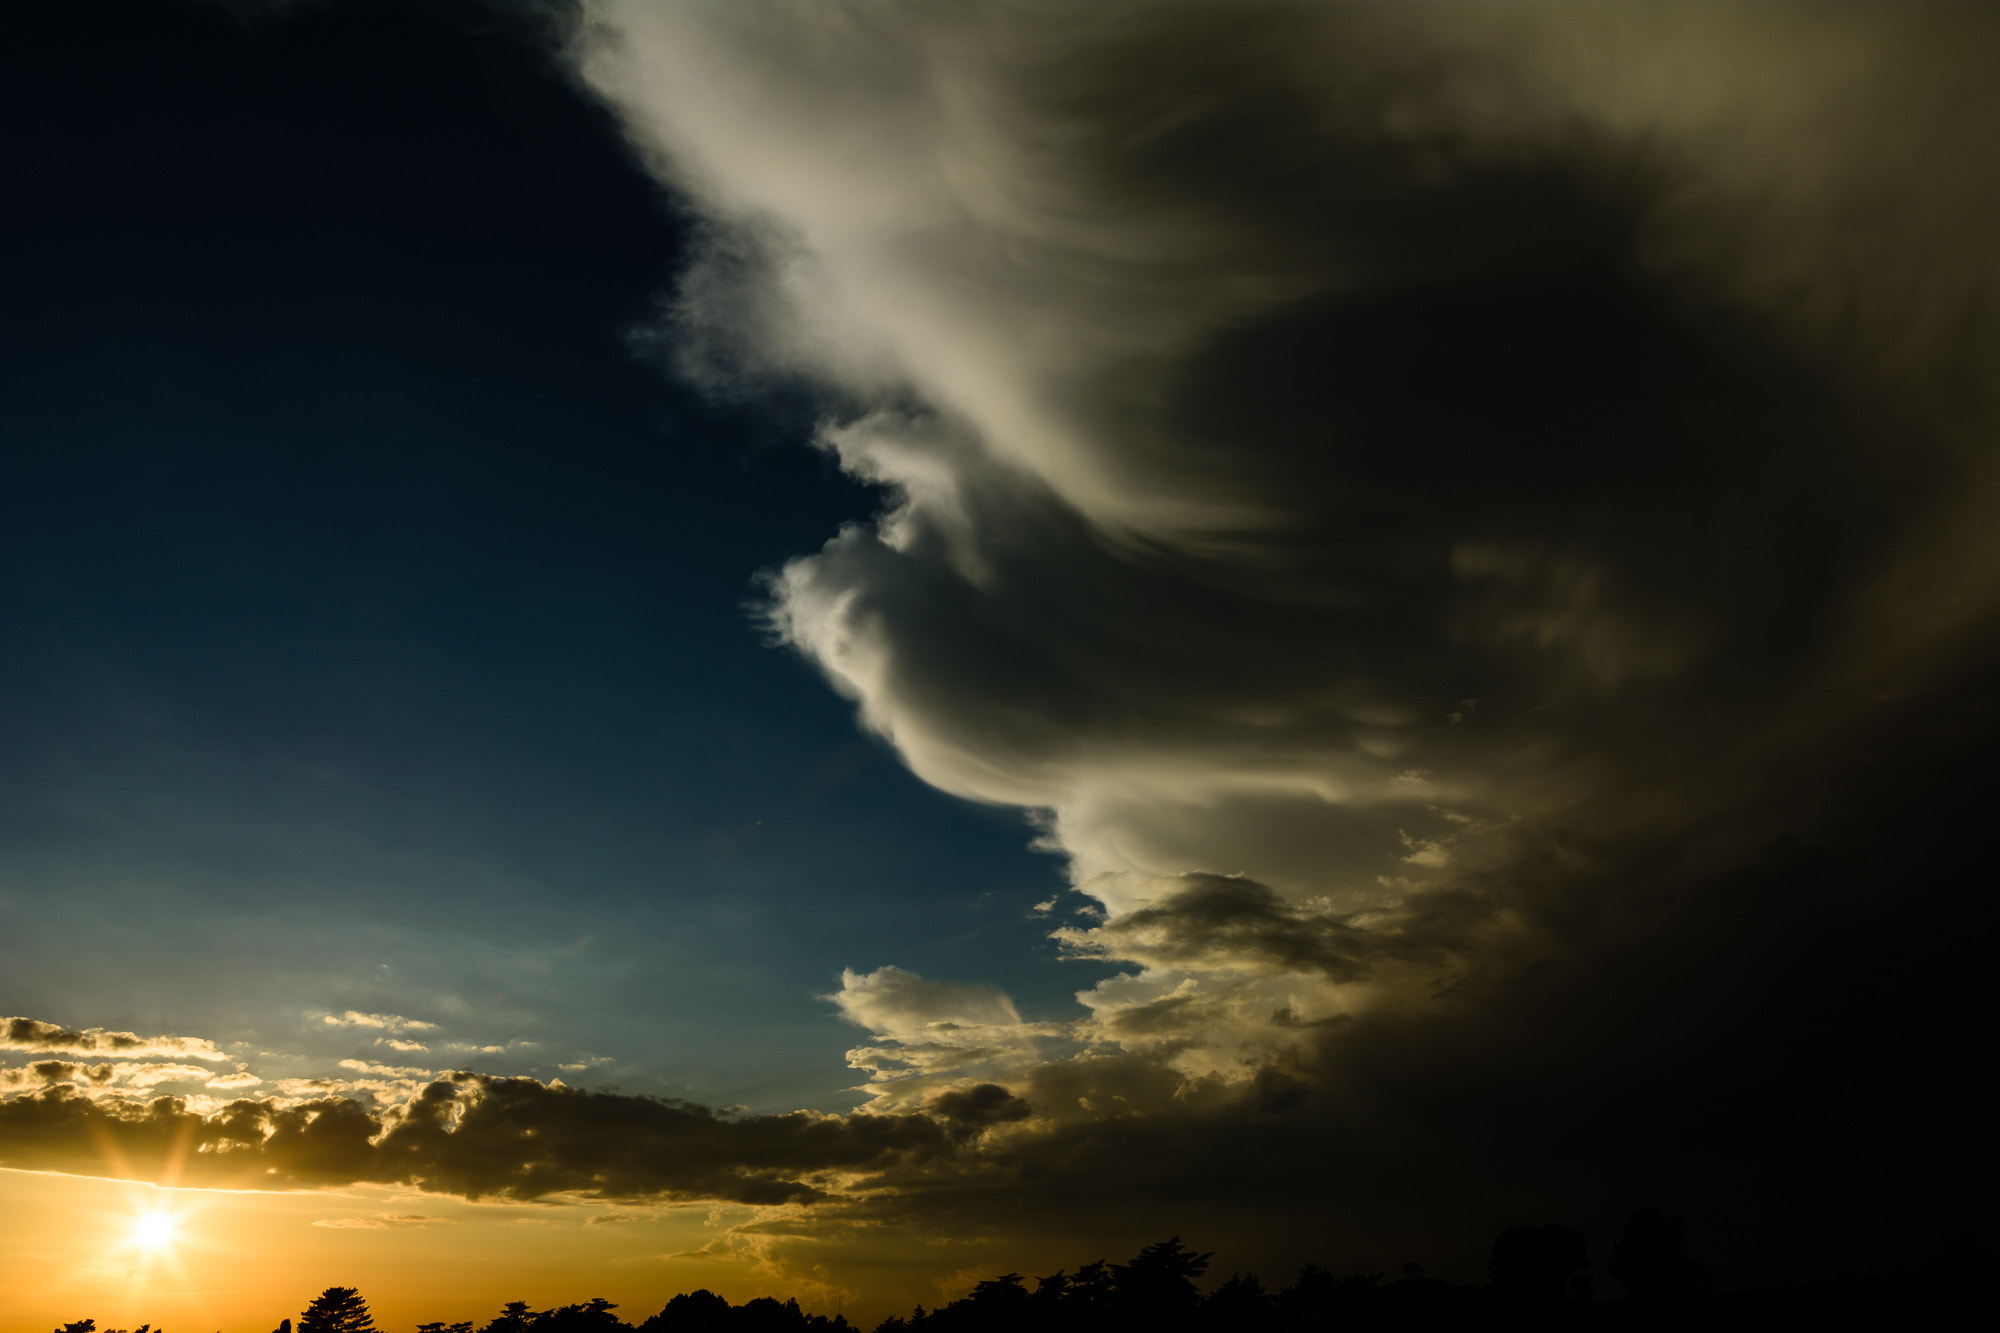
0,1169,856,1333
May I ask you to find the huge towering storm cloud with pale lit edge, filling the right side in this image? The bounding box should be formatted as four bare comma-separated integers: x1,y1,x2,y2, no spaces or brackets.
576,0,2000,1288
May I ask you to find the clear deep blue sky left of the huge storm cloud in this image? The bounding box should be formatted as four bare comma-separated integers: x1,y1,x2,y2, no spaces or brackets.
0,0,1102,1109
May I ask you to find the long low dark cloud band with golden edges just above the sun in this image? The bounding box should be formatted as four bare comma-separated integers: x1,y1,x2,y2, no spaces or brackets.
0,1071,950,1205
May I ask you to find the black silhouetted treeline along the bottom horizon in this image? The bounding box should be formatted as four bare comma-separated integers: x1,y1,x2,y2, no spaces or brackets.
56,1209,1994,1333
